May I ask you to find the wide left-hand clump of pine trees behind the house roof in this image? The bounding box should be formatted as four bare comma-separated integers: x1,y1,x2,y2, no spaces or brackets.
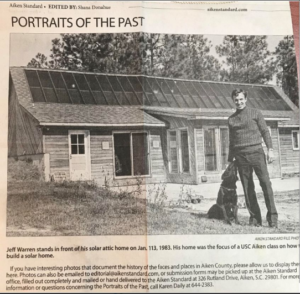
28,33,220,80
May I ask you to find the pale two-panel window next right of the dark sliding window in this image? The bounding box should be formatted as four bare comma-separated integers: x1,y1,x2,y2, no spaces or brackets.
168,129,190,173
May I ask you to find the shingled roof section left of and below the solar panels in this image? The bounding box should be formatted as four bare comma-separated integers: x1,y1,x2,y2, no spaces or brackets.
11,68,165,127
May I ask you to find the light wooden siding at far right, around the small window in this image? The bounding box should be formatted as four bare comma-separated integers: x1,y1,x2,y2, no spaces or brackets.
279,128,299,177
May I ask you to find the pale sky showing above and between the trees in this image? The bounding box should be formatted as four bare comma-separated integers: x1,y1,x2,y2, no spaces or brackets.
9,34,284,84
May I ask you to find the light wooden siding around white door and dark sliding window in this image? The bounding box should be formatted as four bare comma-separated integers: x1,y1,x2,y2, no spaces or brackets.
44,128,166,186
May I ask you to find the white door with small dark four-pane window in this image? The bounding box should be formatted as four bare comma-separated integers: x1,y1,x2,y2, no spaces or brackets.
69,131,91,181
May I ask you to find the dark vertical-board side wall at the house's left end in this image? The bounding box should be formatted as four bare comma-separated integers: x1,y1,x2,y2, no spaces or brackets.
8,83,43,156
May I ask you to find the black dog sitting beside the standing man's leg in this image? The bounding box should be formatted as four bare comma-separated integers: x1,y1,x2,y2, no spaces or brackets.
207,162,239,225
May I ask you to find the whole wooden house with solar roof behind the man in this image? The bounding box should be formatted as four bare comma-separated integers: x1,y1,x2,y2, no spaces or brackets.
8,67,299,185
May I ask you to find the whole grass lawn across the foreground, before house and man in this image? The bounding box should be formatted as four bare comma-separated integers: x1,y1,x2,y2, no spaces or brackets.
7,160,299,237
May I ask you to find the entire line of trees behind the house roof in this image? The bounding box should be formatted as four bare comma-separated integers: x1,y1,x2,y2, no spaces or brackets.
28,33,299,105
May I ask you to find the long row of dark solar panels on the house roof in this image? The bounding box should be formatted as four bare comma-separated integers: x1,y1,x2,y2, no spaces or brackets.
25,69,291,110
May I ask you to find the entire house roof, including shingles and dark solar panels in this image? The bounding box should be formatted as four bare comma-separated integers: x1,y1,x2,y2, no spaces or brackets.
10,67,297,125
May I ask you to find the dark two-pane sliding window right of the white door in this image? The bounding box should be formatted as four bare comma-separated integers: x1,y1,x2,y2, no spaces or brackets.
114,132,149,177
